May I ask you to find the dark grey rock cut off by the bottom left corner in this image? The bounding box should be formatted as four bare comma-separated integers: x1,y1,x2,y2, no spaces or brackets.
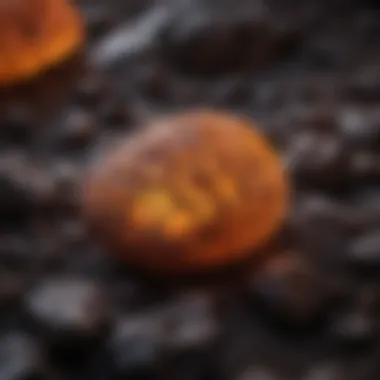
0,332,44,380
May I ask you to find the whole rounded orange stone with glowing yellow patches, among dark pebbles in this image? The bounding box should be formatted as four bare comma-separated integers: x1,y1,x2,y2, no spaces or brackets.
84,110,289,273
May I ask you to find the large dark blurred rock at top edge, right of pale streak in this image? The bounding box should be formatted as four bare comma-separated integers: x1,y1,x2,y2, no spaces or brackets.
159,1,300,74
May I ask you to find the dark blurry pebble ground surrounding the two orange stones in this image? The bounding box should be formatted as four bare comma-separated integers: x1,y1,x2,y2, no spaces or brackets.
0,0,380,380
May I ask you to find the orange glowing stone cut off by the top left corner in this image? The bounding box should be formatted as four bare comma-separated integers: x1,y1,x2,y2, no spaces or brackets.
0,0,85,85
